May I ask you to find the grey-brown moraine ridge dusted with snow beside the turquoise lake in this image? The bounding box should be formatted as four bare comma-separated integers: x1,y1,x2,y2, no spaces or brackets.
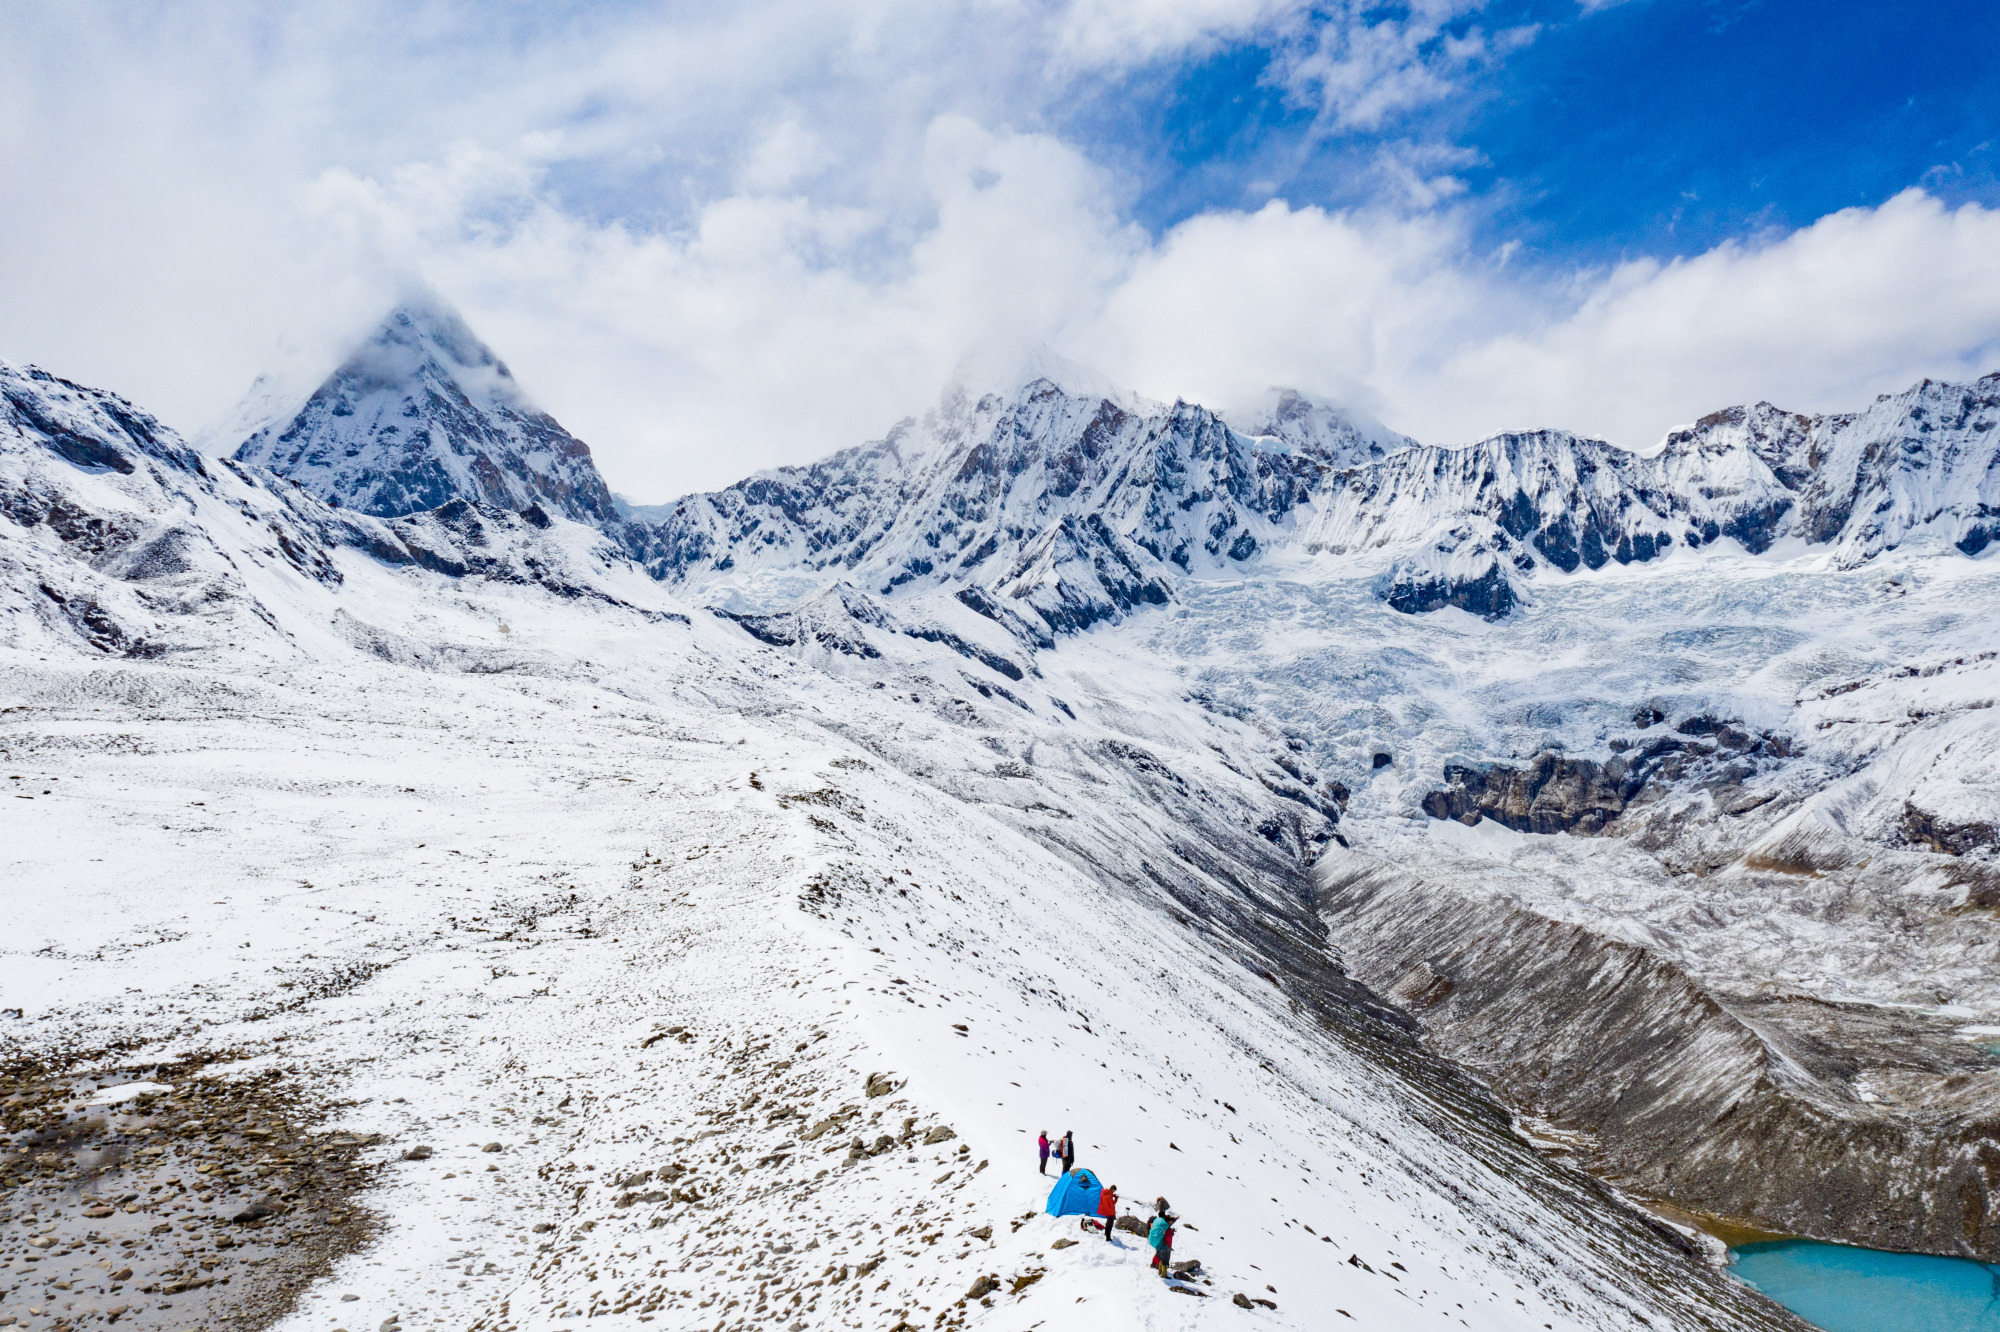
1320,850,2000,1262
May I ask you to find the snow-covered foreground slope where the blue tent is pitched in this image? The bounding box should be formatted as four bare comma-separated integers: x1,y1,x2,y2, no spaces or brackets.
0,352,1794,1330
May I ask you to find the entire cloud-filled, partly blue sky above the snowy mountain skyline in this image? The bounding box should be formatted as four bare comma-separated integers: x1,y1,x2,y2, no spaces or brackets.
0,0,2000,500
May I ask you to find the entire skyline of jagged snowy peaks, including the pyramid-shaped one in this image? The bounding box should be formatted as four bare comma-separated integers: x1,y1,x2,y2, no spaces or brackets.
219,302,2000,632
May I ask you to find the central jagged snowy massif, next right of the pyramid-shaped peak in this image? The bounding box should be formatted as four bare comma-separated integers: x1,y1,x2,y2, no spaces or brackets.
616,364,1334,632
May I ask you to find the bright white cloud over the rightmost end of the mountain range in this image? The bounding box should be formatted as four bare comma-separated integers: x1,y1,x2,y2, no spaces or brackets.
1440,190,2000,446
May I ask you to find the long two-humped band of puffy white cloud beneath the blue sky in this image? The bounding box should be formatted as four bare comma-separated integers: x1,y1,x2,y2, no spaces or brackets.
1092,190,2000,448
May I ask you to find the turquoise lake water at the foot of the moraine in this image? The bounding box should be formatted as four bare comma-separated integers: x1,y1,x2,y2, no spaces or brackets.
1730,1240,2000,1332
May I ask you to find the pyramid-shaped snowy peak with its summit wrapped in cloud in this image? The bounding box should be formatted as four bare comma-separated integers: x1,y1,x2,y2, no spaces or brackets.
236,294,618,524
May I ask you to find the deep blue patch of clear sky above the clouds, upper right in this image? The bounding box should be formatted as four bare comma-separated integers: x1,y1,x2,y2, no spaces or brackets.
1096,0,2000,262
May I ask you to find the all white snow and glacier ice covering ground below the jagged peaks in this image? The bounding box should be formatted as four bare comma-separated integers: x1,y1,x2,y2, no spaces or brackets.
0,352,2000,1332
